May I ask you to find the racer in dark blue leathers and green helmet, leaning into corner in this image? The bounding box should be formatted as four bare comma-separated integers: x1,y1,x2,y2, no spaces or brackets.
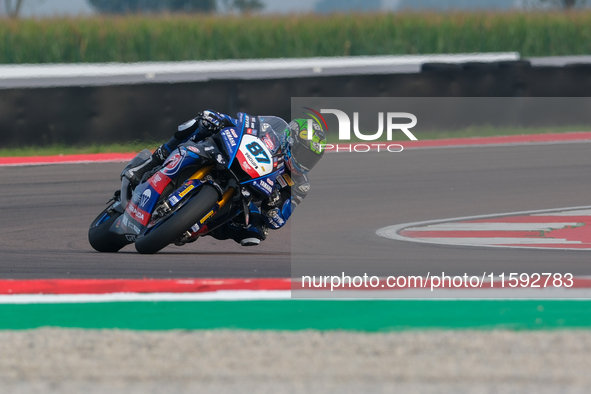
122,110,326,246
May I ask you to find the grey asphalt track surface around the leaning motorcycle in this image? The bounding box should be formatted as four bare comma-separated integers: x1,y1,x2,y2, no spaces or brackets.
0,143,591,278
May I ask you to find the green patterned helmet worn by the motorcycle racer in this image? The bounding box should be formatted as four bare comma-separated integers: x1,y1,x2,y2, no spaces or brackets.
287,119,326,172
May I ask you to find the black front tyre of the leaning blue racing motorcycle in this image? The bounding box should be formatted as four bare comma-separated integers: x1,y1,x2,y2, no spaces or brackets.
135,184,218,254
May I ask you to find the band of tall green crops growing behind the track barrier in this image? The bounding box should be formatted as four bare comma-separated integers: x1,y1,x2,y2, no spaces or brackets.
0,10,591,64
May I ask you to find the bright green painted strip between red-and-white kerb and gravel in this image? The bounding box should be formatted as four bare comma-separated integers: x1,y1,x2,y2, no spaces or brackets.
0,300,591,330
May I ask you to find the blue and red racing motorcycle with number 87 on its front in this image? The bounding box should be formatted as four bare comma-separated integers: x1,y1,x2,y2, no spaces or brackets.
88,113,288,254
